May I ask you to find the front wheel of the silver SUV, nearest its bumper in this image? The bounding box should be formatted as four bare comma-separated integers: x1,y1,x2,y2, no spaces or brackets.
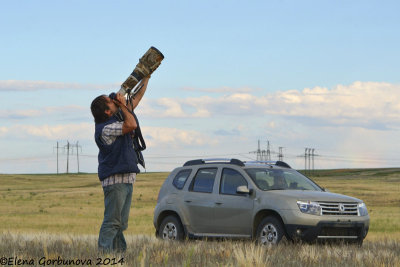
256,216,285,246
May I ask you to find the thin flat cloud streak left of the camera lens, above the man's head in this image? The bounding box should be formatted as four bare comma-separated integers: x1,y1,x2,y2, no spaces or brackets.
0,80,119,92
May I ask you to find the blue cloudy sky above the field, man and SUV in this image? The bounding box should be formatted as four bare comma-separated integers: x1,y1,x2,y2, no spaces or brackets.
0,0,400,173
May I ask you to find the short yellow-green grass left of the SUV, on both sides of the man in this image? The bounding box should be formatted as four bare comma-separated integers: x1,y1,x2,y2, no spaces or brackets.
0,173,168,234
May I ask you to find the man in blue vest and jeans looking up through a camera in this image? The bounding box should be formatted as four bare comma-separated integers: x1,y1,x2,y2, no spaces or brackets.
90,76,150,252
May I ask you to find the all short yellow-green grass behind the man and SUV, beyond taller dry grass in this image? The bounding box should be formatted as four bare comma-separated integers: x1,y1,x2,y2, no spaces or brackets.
0,169,400,239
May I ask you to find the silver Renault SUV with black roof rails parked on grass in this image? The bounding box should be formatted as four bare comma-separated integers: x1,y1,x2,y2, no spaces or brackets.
153,159,369,244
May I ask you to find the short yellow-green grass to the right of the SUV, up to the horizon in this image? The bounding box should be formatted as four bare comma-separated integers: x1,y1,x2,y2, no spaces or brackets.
312,169,400,239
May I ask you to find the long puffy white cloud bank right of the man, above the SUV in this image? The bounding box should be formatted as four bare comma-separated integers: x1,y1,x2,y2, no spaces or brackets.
142,82,400,129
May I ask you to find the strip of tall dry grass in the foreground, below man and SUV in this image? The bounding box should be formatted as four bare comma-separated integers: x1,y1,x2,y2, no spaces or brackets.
0,233,400,267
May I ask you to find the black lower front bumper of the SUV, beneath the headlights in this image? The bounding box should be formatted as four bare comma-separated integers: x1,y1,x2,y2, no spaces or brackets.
285,221,369,241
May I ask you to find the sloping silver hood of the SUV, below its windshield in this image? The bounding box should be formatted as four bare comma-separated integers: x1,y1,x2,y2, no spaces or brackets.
266,190,362,203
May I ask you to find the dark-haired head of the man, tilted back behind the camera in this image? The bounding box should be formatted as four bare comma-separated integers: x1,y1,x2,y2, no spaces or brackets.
90,95,118,123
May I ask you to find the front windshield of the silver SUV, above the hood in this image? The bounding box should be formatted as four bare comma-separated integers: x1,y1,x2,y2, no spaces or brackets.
245,168,322,191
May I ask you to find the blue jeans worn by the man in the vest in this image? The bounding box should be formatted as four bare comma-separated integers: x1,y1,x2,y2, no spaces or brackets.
98,184,133,252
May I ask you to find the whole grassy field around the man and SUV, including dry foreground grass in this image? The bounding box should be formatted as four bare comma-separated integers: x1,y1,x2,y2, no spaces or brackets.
0,169,400,266
